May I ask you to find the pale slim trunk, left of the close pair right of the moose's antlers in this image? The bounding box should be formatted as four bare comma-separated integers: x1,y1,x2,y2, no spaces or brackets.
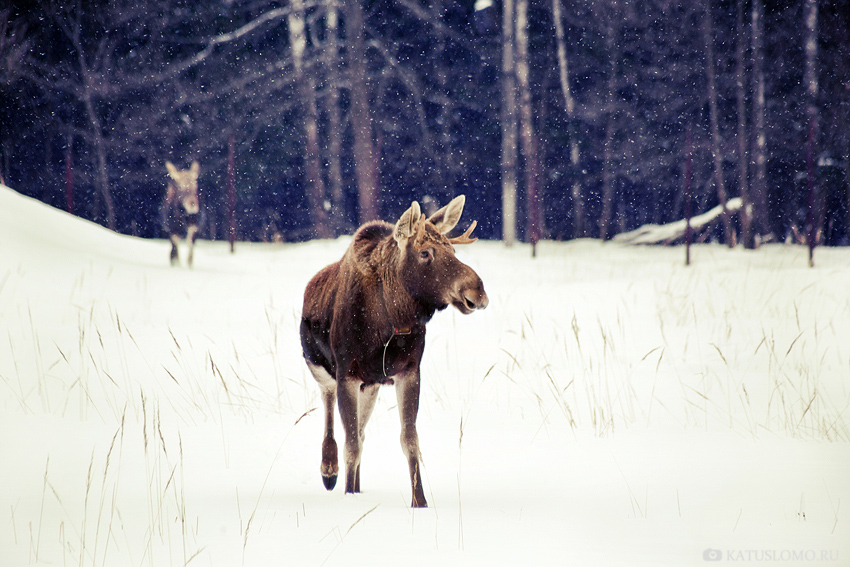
501,0,517,246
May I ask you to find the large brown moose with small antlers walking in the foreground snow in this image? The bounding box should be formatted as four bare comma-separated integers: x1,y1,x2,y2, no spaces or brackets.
301,195,489,508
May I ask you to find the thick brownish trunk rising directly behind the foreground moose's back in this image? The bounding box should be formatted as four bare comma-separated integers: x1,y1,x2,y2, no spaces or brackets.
345,0,378,224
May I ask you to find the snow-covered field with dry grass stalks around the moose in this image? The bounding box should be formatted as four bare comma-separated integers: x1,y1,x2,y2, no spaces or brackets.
0,187,850,567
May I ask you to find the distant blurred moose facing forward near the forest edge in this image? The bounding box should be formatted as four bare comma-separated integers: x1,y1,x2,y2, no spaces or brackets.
161,161,201,268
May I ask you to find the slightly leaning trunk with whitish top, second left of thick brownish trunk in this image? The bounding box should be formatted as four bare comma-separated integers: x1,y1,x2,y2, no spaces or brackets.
288,0,331,238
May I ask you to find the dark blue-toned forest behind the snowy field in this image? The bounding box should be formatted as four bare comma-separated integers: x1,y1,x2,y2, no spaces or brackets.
0,0,850,247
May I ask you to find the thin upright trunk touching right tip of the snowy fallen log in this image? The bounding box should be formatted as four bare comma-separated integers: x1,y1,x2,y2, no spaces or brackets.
735,0,756,250
